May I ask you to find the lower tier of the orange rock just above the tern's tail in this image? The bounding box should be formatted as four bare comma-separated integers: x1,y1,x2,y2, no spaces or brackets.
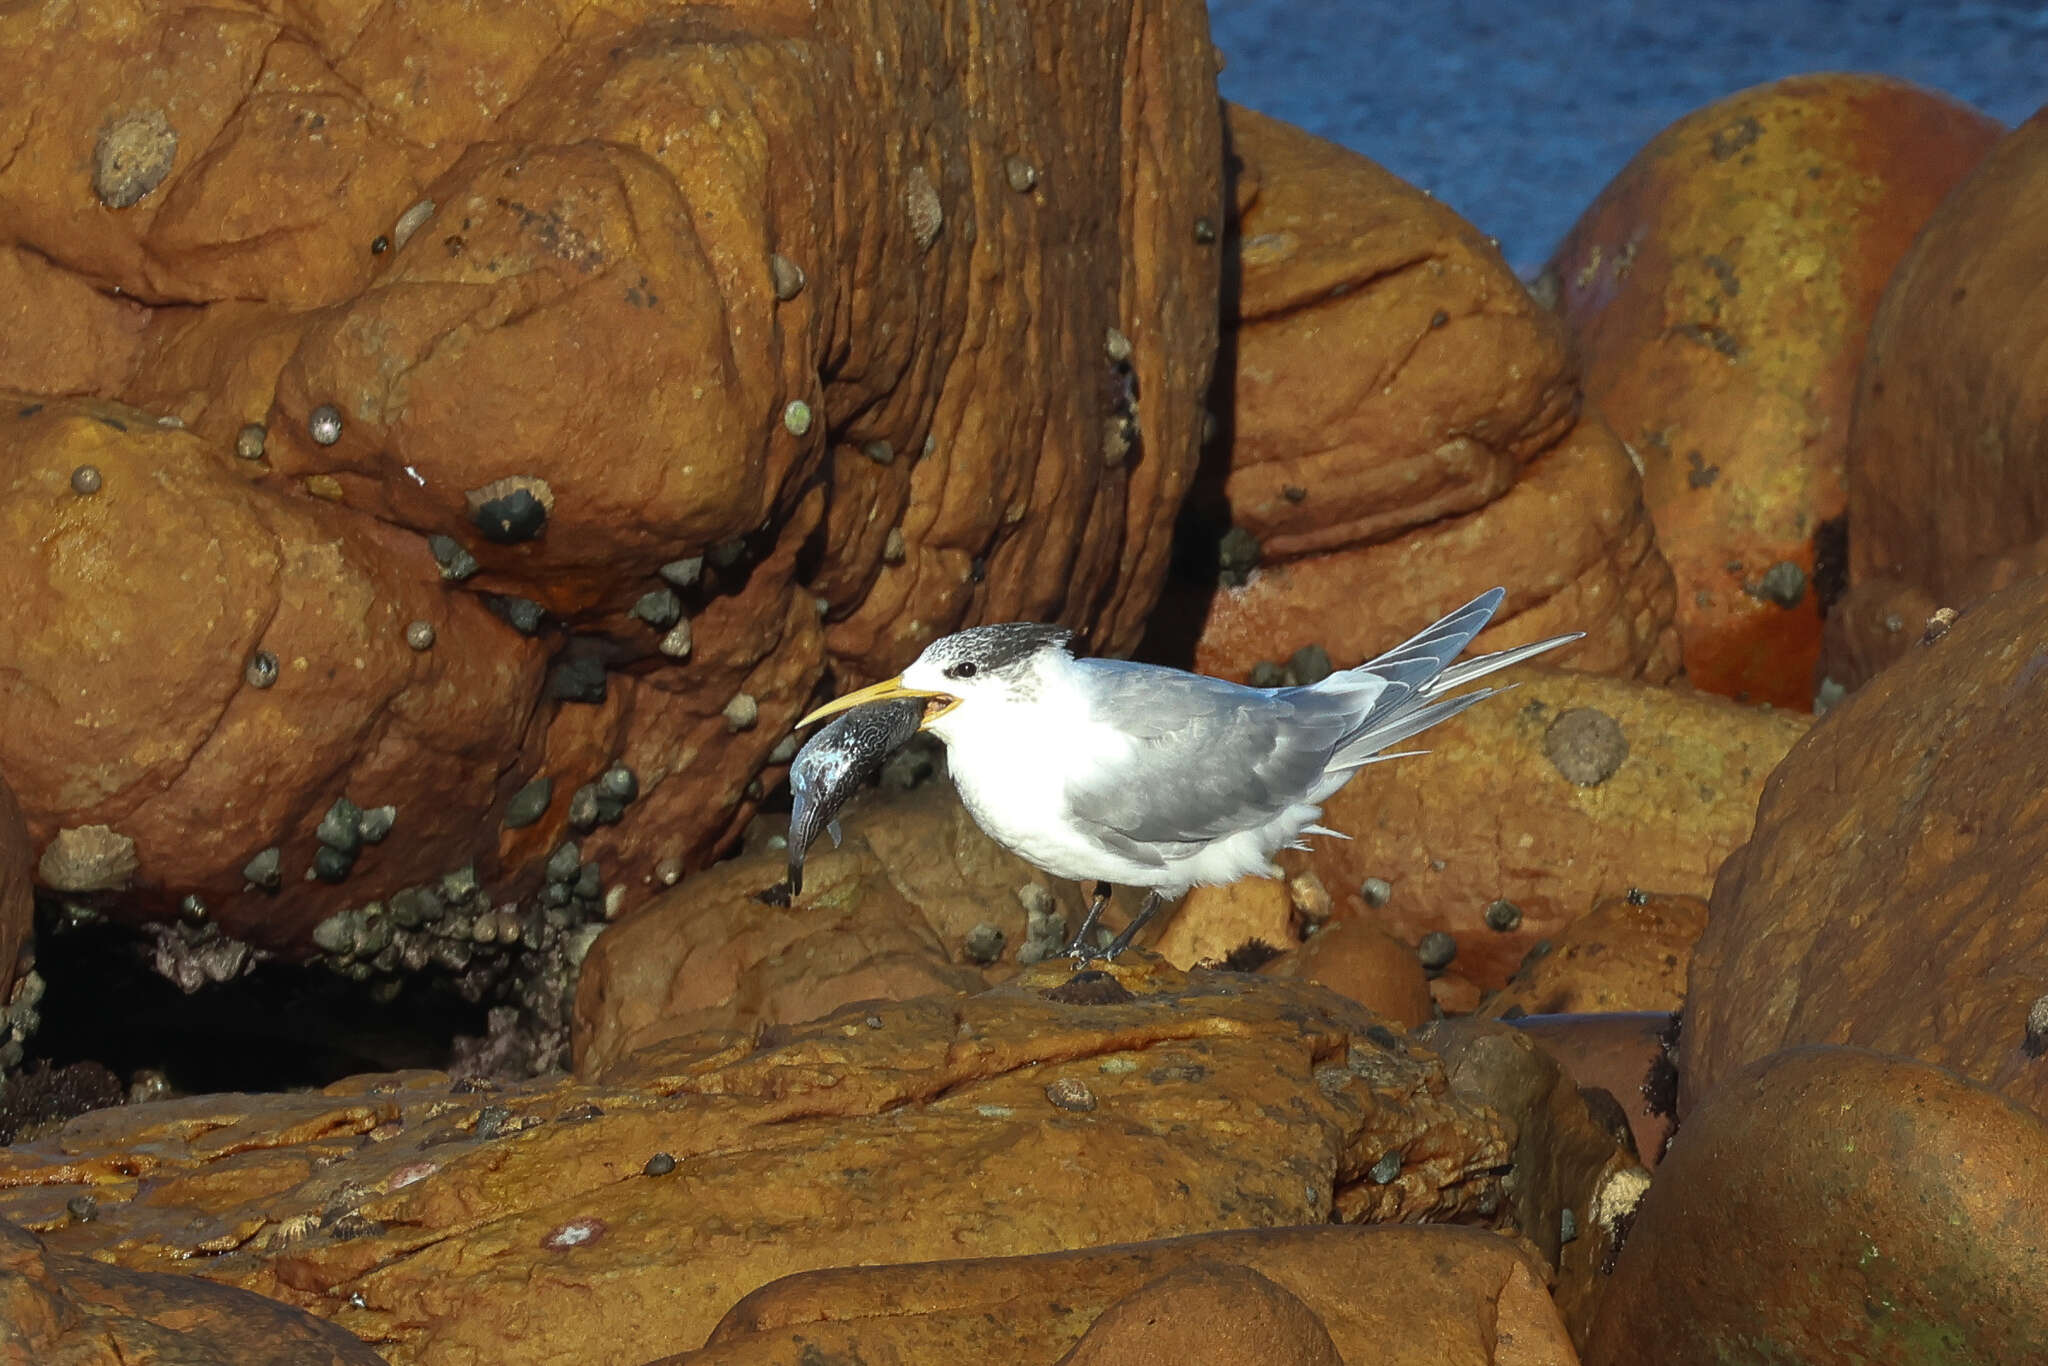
1194,405,1679,682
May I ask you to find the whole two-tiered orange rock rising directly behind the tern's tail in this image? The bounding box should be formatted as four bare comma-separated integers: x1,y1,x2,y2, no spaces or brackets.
1153,109,1677,696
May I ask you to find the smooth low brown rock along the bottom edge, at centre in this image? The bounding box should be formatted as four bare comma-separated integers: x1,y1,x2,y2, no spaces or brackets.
679,1227,1577,1366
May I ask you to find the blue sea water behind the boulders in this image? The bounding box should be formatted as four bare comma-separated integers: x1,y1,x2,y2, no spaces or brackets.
1208,0,2048,272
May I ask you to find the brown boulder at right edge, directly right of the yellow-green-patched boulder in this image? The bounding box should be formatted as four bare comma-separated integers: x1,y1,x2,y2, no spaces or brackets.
1829,105,2048,686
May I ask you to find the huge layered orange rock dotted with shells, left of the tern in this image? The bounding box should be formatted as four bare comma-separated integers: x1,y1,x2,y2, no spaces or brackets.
0,0,1223,954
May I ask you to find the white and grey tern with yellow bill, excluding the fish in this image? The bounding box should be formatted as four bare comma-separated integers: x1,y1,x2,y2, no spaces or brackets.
797,588,1583,961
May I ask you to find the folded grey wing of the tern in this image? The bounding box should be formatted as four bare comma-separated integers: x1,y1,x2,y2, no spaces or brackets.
1067,659,1360,844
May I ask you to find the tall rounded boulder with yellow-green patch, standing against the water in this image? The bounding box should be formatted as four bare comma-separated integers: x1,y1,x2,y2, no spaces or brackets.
1544,74,1999,711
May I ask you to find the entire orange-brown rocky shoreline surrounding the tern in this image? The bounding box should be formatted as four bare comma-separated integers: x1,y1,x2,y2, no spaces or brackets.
0,0,2048,1366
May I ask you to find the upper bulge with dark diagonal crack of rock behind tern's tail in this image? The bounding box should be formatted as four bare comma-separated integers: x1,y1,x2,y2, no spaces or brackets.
1223,106,1577,561
